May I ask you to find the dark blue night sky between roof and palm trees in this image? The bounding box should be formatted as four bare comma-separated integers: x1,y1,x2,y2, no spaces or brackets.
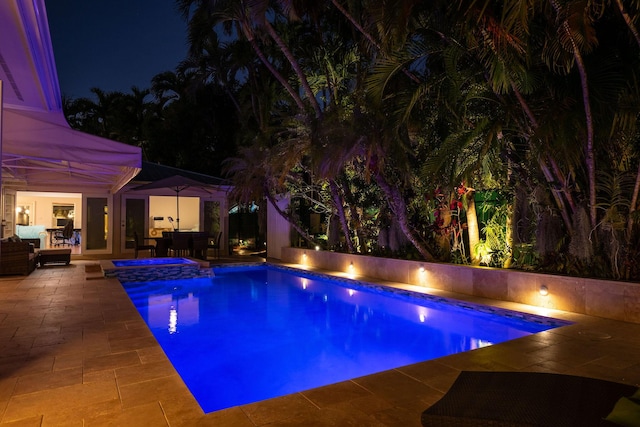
45,0,187,98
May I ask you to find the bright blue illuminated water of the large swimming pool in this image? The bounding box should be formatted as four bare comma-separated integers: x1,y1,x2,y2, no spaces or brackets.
123,267,567,412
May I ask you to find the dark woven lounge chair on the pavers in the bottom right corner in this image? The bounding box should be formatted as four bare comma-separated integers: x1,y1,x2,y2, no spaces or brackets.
421,371,638,427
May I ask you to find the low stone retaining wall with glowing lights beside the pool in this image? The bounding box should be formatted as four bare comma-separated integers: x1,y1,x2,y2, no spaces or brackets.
281,247,640,323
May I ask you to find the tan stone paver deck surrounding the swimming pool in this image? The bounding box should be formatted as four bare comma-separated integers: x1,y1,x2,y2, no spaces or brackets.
0,261,640,427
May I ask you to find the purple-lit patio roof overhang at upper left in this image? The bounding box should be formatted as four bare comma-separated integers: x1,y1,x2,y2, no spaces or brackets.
0,0,142,193
